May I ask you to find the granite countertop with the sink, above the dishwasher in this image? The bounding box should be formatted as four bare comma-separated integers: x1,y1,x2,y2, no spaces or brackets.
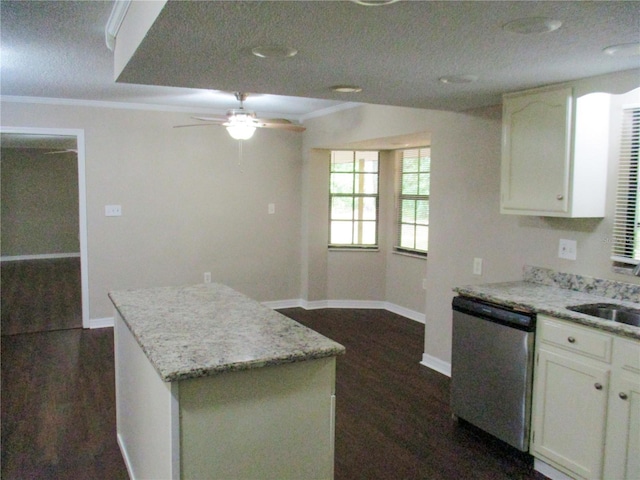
453,281,640,340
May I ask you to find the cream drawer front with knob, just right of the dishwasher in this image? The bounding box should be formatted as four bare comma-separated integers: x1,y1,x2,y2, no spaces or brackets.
538,317,613,363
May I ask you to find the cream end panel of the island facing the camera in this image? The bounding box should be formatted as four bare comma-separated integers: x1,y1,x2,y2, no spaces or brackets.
180,358,335,480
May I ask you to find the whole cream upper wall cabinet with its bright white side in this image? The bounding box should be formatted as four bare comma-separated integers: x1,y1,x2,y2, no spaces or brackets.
500,86,610,217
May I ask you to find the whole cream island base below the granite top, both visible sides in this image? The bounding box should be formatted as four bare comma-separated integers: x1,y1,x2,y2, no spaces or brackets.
115,313,335,480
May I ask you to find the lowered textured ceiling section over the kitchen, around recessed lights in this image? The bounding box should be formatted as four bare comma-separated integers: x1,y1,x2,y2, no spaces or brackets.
119,1,640,110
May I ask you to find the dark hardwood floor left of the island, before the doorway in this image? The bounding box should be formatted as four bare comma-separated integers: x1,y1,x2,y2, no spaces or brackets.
1,328,128,480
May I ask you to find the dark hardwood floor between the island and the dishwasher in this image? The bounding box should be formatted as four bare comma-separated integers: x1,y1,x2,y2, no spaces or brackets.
280,308,546,480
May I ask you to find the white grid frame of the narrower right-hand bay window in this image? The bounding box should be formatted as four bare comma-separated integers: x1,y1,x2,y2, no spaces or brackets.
393,145,431,258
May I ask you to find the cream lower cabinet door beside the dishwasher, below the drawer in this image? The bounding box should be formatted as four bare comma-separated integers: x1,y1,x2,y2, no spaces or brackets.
532,347,610,478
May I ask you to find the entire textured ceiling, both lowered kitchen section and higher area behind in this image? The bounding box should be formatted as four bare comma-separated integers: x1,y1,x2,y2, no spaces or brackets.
0,0,640,120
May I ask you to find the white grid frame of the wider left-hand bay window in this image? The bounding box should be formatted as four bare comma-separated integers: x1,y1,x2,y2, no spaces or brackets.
328,150,380,251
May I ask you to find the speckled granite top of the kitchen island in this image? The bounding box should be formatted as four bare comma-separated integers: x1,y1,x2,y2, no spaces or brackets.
109,283,345,382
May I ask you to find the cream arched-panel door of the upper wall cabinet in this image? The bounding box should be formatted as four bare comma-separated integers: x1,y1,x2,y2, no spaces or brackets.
501,88,572,215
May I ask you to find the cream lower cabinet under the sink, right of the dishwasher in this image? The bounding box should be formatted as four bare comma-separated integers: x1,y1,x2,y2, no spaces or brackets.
531,315,640,480
